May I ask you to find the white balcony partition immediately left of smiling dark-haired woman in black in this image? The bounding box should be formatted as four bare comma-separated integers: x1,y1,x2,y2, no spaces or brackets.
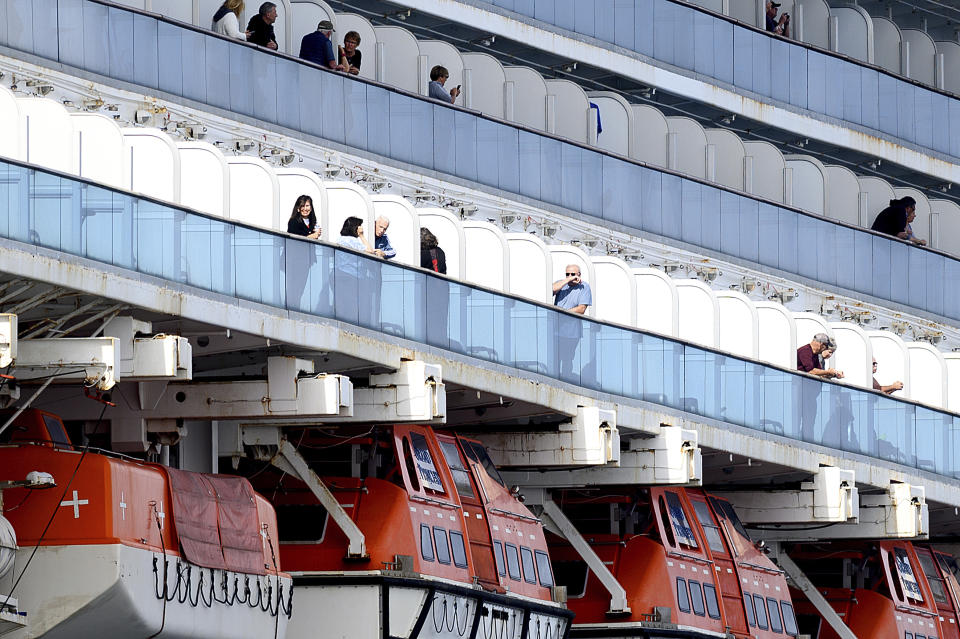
227,155,280,230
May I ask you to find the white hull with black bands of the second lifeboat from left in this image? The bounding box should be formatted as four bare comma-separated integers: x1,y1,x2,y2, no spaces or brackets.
287,573,573,639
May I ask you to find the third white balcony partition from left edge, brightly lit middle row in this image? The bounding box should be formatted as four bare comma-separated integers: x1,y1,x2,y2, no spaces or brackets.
70,113,124,188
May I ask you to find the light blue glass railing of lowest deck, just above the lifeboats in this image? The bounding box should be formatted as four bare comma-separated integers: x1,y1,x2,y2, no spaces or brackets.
0,161,960,477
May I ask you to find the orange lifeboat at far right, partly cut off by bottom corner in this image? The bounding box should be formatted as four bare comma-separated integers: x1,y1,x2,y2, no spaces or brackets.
788,540,960,639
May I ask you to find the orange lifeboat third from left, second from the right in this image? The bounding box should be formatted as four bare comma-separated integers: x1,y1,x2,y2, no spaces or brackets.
550,487,798,639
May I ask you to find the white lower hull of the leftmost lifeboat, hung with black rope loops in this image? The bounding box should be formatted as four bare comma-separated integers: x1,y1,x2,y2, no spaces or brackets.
0,544,291,639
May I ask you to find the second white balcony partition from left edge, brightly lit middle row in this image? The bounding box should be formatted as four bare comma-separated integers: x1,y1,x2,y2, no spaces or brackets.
17,98,77,175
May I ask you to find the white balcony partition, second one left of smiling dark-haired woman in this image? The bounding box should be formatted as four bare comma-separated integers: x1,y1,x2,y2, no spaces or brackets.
177,141,230,219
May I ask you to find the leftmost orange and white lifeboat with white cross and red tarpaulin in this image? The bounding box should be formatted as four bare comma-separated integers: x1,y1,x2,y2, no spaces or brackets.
0,409,292,639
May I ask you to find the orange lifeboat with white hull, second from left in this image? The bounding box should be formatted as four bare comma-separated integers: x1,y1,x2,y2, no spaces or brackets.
241,425,573,639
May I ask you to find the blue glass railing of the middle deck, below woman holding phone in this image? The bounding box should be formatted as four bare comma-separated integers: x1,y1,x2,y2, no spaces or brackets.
0,0,960,330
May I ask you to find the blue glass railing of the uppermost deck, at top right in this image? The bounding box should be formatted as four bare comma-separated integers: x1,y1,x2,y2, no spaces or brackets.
470,0,960,158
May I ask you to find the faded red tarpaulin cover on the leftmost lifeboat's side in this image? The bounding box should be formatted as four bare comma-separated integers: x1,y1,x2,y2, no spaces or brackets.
164,467,266,575
